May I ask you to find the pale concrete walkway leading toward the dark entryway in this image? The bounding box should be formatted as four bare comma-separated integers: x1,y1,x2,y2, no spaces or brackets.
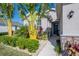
38,37,57,56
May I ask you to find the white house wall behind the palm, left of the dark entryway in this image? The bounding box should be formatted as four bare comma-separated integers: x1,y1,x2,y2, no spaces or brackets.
41,11,57,31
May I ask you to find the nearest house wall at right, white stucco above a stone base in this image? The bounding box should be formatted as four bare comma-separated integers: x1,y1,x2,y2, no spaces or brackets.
57,3,79,50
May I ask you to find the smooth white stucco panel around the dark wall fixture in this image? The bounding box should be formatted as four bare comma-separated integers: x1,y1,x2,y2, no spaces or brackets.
62,4,79,36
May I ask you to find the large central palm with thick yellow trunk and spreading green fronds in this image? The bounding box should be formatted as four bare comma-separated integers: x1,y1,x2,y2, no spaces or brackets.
20,3,49,39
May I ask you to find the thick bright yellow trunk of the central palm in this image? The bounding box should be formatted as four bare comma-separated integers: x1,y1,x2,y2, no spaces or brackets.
29,14,37,39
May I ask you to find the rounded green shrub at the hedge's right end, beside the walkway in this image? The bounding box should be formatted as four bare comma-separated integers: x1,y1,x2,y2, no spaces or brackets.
28,39,39,53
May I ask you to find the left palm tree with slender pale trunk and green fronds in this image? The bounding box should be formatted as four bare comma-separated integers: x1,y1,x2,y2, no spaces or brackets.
0,3,13,36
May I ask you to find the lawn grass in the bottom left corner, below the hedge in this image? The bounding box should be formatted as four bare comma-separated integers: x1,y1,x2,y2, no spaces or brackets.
0,44,29,56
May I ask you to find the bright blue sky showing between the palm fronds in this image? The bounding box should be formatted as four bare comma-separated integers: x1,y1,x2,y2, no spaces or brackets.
12,3,56,24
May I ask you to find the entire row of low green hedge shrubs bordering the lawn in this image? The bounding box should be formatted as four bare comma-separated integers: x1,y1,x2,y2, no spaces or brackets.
0,36,39,53
